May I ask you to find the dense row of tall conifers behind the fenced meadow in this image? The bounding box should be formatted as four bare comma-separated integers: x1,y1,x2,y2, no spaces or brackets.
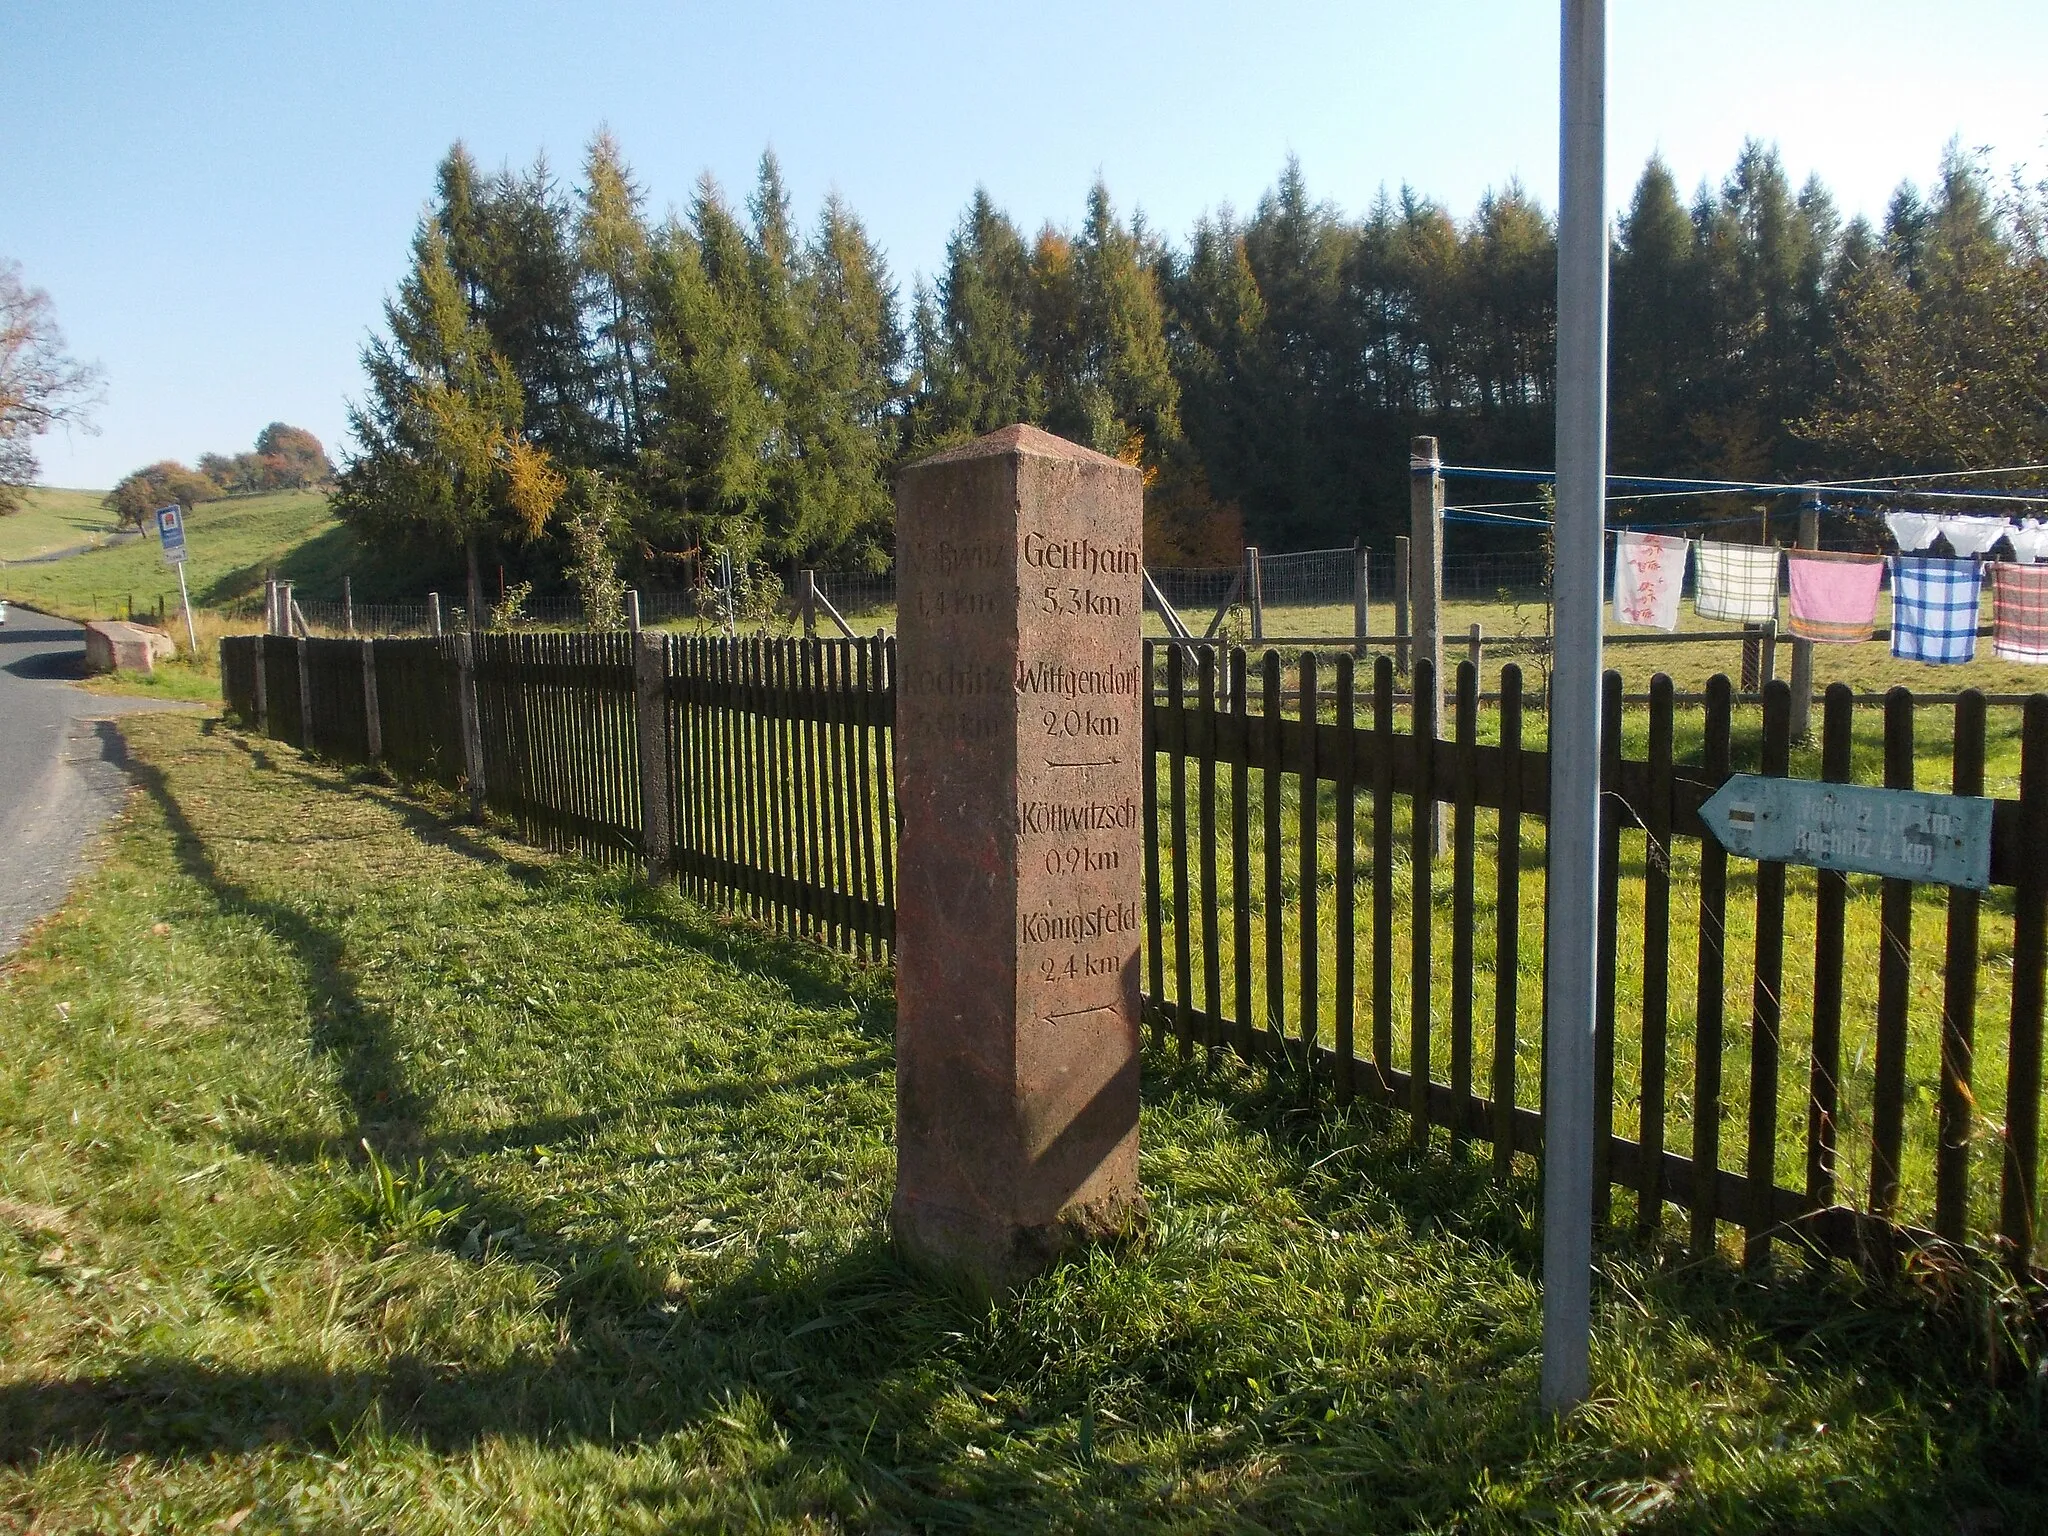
336,131,2048,604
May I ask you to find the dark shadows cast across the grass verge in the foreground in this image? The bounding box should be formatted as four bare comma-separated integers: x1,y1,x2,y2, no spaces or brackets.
0,729,2048,1530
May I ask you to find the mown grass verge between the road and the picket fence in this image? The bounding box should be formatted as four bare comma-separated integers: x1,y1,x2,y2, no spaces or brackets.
0,717,2048,1532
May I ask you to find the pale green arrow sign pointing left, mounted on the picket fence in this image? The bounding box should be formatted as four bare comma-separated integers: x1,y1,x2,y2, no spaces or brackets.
1700,774,1991,891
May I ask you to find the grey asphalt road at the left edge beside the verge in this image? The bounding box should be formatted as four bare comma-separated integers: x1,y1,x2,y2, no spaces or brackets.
0,604,191,954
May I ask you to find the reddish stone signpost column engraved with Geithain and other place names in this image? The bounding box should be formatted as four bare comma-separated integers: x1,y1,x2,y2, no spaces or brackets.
893,426,1145,1290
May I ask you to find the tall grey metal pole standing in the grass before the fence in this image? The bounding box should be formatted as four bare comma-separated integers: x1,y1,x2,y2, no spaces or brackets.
1542,0,1608,1411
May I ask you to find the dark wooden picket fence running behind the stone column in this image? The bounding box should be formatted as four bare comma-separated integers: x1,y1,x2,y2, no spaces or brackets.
221,635,2048,1274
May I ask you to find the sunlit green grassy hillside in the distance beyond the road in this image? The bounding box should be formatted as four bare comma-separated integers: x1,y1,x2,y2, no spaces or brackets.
0,492,452,618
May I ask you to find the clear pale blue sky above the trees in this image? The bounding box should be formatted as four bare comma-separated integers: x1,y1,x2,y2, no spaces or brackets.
0,0,2048,485
